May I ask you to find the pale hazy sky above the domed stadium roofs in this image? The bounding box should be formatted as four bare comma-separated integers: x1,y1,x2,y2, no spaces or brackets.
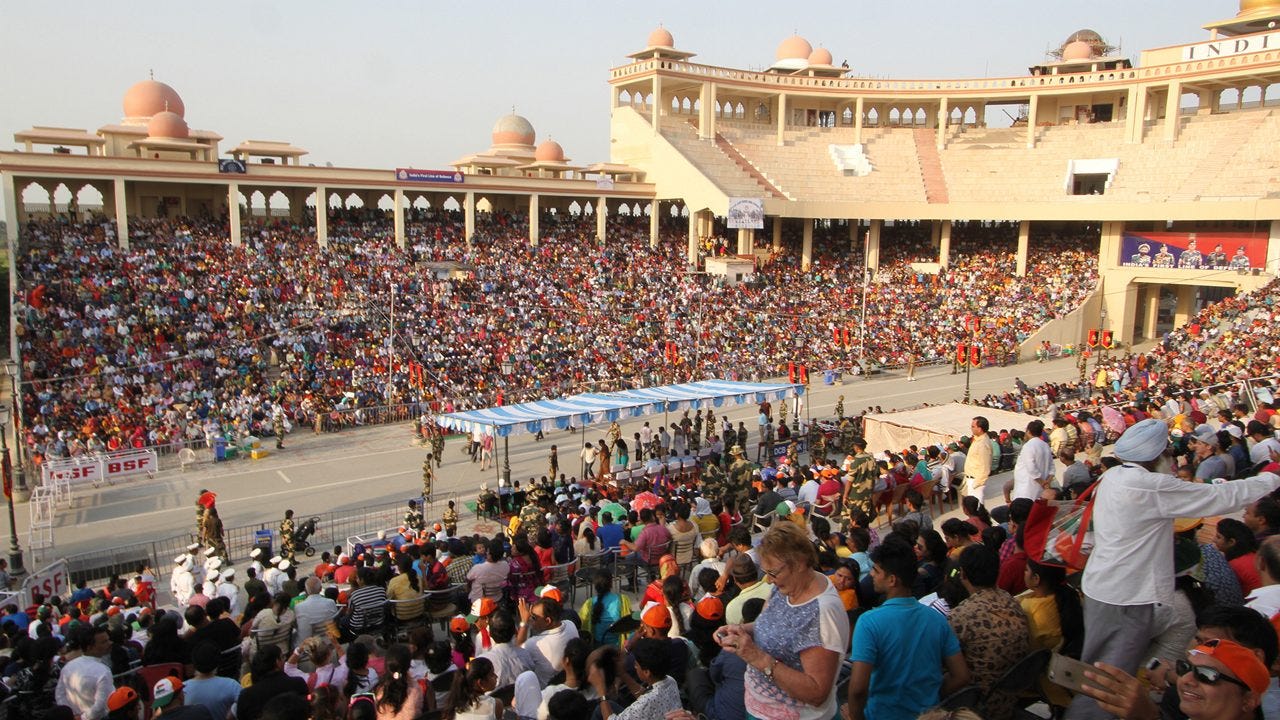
0,0,1238,174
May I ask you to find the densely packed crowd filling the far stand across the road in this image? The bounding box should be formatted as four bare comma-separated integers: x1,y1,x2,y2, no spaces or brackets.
14,209,1096,468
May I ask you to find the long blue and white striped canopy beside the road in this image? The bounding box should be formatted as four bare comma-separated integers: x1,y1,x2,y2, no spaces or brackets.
435,380,804,437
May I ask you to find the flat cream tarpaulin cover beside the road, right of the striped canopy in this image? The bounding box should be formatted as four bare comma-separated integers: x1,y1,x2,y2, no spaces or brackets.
863,402,1036,455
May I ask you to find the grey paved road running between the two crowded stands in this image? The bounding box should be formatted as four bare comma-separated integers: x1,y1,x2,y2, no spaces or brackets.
27,351,1078,556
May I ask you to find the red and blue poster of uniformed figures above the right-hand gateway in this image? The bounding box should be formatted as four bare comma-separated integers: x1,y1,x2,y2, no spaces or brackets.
1120,232,1267,270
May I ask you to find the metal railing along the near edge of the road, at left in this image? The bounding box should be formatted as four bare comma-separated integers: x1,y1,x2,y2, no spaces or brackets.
61,492,458,588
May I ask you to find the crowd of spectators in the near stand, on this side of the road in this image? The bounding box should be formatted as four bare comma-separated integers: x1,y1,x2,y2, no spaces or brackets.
0,389,1280,720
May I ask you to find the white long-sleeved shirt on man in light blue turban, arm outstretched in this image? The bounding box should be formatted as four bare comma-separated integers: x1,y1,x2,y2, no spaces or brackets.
1083,464,1280,605
